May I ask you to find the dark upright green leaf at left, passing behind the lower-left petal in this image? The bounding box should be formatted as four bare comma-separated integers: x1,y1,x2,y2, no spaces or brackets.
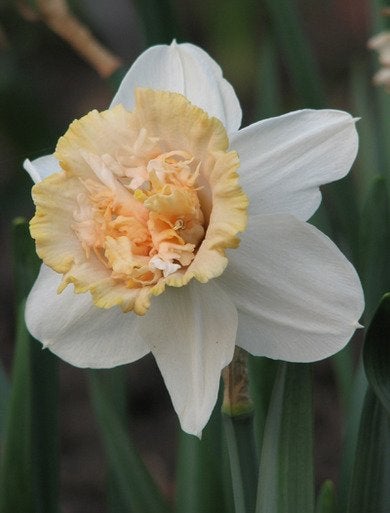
14,218,59,513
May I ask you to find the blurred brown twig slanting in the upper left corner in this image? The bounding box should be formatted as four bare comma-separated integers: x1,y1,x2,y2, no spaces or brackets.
19,0,122,78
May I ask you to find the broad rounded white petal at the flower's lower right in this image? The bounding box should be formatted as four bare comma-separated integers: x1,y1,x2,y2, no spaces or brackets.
221,215,364,362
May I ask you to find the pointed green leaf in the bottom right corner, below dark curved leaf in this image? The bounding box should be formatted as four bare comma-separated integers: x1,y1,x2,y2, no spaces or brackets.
347,389,390,513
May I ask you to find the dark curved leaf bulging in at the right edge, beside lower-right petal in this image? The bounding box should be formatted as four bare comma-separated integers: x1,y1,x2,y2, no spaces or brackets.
363,293,390,414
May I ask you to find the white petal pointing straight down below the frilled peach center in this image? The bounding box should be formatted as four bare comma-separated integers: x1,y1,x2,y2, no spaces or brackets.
142,280,237,436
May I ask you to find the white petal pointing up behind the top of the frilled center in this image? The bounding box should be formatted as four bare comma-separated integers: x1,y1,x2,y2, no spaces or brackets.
111,41,241,133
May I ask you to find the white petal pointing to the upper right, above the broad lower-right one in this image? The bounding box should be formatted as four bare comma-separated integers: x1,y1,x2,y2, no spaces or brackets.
231,110,358,220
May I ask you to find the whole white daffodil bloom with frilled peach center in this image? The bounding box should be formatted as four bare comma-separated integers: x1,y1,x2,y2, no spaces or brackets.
25,43,363,435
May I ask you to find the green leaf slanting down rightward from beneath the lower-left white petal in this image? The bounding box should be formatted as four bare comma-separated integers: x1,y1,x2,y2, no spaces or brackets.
88,371,170,513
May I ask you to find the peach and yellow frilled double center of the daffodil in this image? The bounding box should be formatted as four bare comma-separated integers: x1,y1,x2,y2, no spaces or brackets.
31,89,247,315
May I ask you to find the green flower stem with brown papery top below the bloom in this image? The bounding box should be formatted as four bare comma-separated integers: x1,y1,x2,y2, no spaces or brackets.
222,348,258,513
